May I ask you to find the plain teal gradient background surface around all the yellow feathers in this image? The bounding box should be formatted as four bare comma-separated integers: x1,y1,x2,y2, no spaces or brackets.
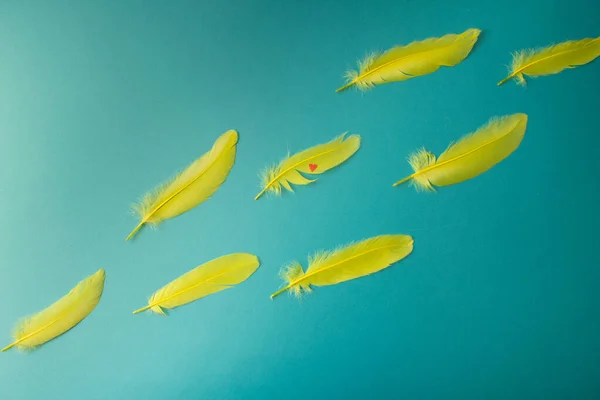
0,0,600,400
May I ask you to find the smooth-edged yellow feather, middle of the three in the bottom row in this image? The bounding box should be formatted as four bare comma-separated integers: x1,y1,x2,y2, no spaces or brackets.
133,253,259,315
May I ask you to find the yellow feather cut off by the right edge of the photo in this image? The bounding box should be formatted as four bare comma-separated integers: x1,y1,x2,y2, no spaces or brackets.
498,37,600,86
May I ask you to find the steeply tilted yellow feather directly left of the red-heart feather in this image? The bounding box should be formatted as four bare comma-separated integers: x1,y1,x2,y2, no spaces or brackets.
126,130,238,240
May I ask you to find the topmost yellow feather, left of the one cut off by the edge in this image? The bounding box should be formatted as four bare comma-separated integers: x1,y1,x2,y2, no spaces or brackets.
336,29,481,92
